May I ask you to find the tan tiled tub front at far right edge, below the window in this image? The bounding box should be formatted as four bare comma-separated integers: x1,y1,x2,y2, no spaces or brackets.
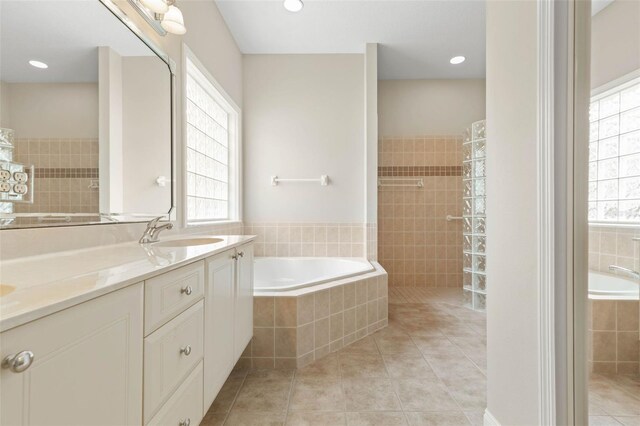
589,300,640,375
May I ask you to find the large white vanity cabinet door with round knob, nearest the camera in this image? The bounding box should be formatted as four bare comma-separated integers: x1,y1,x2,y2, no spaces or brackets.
0,283,143,426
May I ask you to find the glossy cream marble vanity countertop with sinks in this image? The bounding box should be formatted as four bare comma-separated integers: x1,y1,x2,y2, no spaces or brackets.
0,235,255,332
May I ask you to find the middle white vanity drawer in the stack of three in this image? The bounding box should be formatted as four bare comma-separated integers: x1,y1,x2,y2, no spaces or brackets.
144,300,204,423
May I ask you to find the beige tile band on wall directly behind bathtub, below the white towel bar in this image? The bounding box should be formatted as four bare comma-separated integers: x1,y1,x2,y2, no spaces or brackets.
244,223,366,257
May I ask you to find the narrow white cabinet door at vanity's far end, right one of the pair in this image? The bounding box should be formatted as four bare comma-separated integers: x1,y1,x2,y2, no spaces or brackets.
234,244,253,361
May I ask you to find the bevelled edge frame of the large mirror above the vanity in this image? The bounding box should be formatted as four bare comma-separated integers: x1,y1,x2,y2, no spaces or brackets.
0,0,177,231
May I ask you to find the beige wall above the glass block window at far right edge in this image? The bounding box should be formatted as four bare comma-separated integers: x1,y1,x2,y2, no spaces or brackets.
591,0,640,88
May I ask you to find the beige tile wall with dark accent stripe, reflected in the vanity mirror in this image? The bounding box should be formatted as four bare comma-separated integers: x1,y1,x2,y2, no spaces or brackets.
13,139,99,213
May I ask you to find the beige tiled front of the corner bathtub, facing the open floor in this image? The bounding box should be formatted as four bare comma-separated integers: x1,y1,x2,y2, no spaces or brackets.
240,271,388,369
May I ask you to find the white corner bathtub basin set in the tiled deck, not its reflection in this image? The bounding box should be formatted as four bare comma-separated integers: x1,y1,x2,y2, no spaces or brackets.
253,257,375,293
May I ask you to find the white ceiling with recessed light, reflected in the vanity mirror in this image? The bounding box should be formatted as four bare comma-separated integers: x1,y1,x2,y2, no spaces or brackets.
0,0,160,83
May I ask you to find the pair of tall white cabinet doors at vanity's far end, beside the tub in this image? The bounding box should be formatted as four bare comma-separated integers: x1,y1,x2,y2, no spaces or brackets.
204,243,253,412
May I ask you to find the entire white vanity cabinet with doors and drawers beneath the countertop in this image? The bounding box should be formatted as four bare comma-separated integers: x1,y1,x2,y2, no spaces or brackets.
0,242,253,426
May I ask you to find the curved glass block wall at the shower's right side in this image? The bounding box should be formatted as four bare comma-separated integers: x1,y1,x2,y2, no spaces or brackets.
462,120,487,311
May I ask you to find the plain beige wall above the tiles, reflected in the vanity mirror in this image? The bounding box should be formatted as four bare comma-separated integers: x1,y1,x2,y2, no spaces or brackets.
2,83,98,139
